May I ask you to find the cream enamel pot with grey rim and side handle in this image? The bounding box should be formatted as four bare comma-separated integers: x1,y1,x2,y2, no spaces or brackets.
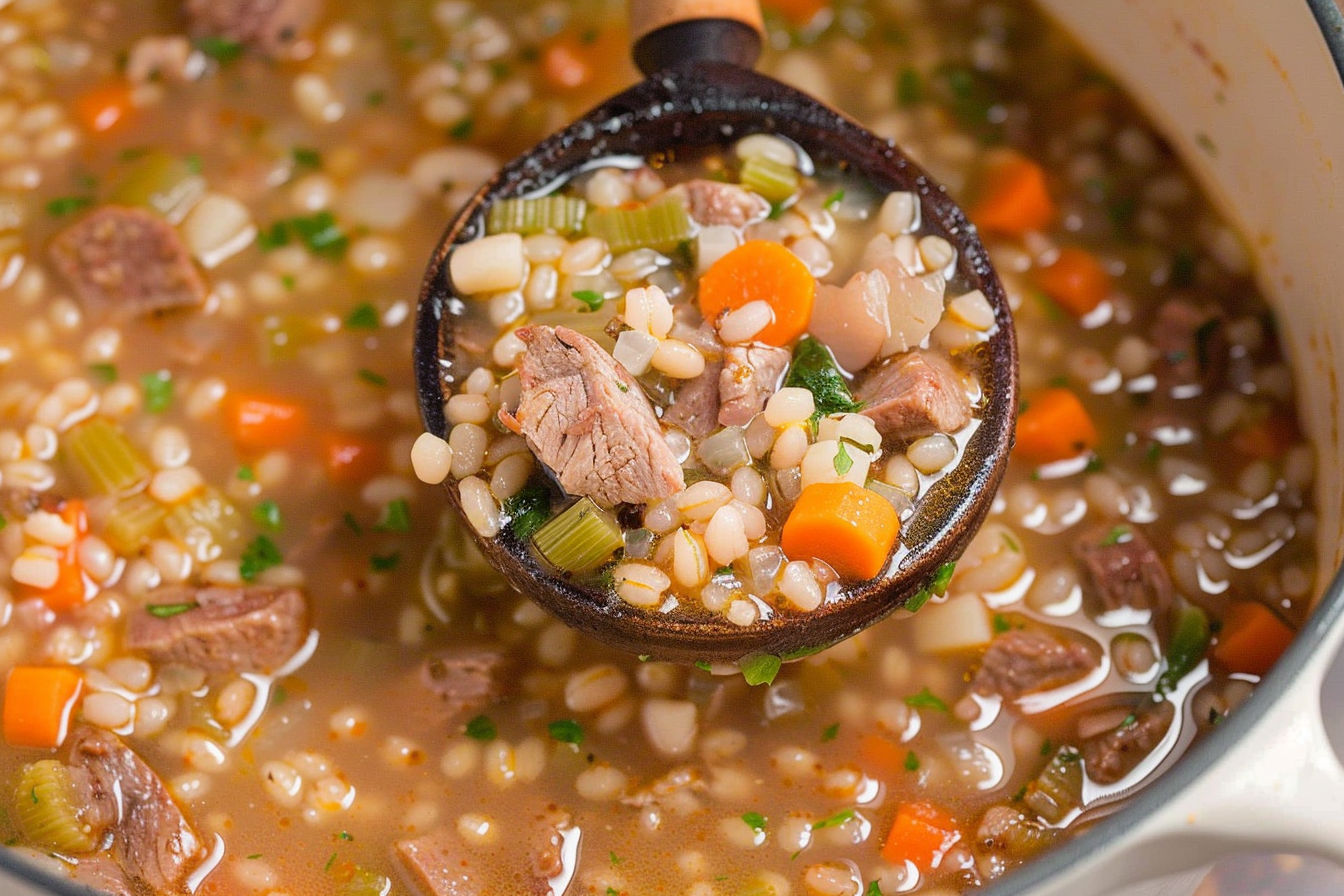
0,0,1344,896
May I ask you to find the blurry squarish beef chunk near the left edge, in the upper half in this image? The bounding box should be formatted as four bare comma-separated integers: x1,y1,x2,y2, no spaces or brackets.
51,206,207,316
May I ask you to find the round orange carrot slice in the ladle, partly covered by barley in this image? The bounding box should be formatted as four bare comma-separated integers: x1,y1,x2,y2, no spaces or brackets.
700,239,817,345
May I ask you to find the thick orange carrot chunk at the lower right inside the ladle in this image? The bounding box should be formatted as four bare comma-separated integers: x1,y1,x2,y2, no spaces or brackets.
780,482,900,579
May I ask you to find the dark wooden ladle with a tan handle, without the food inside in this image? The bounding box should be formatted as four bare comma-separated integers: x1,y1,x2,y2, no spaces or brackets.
415,0,1017,665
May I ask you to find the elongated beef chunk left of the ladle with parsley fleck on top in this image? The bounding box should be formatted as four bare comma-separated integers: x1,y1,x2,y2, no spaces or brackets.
126,586,308,672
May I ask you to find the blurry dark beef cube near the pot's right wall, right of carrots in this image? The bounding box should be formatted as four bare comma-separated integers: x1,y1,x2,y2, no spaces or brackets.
1149,298,1227,398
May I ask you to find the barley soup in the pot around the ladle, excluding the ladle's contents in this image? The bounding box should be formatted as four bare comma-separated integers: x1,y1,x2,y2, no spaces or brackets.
0,0,1316,896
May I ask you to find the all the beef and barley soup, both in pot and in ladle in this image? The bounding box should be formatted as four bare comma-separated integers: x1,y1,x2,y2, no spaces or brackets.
0,0,1316,896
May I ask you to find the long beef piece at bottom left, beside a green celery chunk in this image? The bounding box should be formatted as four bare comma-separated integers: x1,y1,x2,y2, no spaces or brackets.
66,727,204,892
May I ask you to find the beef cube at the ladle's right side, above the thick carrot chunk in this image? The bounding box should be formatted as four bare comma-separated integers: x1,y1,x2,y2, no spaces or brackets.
855,349,970,442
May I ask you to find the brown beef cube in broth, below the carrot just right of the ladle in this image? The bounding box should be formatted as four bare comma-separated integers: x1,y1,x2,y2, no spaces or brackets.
1073,523,1173,622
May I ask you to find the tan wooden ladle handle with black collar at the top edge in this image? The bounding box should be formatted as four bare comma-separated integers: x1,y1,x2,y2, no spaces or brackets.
630,0,765,75
